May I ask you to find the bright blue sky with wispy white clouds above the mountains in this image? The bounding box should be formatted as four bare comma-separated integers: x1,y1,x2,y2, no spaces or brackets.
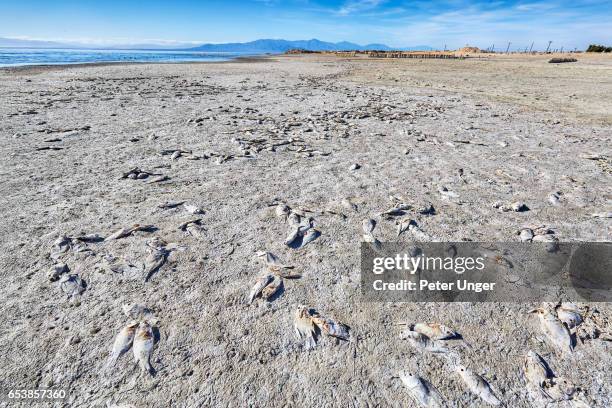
0,0,612,49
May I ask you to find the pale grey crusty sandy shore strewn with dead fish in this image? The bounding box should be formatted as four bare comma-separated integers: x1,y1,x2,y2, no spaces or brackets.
0,55,612,407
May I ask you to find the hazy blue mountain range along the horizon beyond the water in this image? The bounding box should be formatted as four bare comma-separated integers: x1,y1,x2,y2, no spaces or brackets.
0,37,433,54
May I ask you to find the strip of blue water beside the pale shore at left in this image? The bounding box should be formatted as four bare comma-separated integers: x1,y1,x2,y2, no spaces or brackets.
0,48,247,67
